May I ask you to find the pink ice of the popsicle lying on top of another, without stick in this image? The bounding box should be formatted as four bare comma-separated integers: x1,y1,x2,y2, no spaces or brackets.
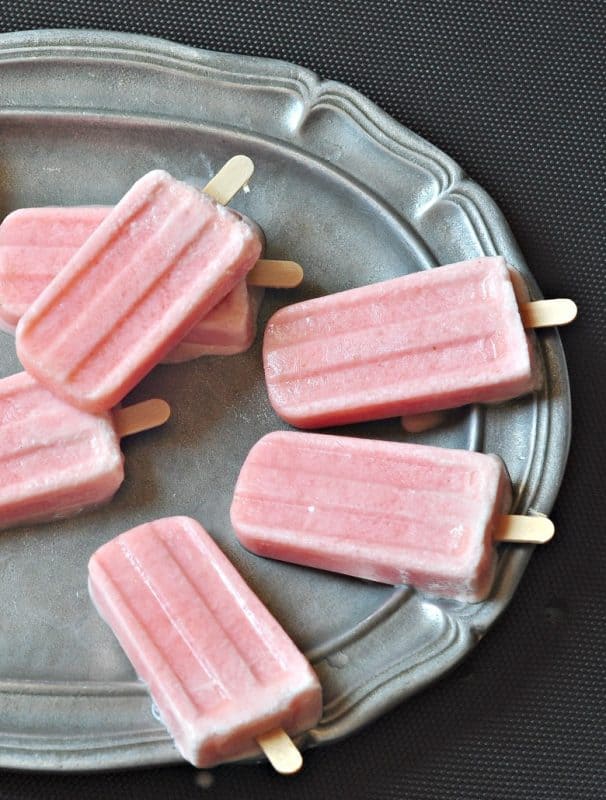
17,162,261,412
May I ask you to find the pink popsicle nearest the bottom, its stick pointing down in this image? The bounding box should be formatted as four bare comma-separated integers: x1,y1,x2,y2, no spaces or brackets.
89,517,322,771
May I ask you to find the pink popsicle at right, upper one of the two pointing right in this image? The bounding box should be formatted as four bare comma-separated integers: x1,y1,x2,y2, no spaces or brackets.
263,257,576,428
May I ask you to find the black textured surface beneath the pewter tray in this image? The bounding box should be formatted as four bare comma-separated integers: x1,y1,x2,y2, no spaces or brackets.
0,0,606,800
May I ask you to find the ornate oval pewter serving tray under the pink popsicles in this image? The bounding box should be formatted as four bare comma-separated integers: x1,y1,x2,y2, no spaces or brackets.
0,31,570,769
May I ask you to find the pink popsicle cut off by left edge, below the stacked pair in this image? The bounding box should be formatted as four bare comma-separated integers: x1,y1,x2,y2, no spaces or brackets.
0,372,170,528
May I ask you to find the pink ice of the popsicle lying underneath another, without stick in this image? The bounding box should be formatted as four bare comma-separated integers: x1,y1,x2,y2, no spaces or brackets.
0,206,261,362
